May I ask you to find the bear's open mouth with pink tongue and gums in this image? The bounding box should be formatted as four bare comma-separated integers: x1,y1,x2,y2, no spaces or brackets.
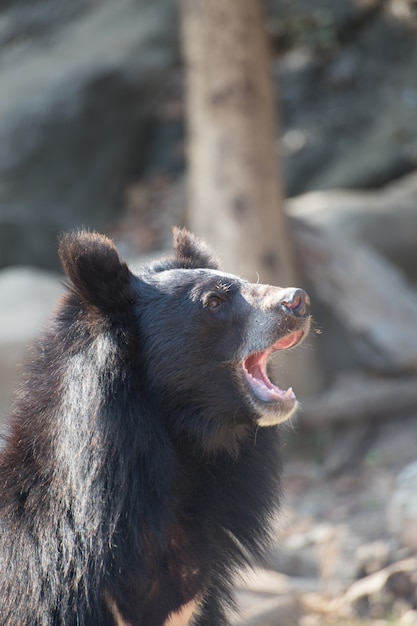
242,330,304,402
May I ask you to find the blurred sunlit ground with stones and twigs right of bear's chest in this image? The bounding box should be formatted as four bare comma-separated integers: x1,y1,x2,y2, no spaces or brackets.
231,415,417,626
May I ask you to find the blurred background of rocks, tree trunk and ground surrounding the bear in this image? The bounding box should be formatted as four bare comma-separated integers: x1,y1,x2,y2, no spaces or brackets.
0,0,417,626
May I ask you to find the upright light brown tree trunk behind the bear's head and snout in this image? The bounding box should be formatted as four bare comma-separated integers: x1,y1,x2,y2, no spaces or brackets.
180,0,318,393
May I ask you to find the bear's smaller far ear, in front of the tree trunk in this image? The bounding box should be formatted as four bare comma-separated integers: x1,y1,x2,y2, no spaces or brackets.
173,226,219,270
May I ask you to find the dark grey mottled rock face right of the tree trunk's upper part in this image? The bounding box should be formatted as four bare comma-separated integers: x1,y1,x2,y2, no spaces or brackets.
270,0,417,196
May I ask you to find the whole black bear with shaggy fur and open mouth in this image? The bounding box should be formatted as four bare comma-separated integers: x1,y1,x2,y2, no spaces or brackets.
0,230,309,626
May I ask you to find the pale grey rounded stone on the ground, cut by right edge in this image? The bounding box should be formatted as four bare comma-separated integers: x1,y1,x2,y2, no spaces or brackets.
386,461,417,550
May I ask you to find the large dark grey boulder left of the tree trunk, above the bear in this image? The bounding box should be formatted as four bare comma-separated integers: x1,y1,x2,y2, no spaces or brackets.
0,0,177,267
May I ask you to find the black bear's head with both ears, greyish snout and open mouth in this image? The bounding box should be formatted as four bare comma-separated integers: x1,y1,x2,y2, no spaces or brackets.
60,229,310,451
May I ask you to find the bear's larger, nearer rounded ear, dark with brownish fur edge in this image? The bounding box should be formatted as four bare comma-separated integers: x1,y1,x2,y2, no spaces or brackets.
58,231,134,311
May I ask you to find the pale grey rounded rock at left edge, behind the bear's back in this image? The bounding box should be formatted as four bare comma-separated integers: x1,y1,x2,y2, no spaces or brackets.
0,268,64,417
